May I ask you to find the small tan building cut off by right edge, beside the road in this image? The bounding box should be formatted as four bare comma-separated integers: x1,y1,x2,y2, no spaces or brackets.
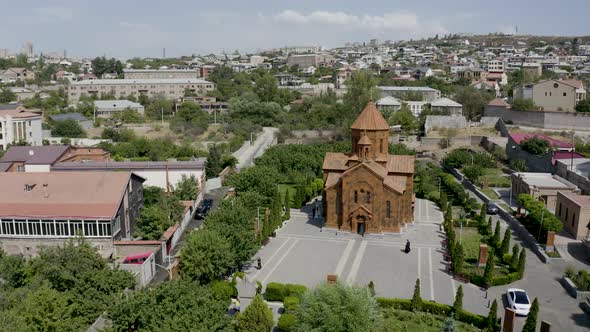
555,191,590,240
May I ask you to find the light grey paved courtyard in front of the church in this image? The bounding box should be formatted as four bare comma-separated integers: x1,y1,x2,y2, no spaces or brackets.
247,199,489,315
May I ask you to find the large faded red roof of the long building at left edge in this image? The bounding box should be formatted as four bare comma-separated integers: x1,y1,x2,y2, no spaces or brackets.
0,172,138,220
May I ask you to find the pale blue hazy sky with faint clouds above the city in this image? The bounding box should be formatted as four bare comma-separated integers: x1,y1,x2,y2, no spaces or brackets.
0,0,590,58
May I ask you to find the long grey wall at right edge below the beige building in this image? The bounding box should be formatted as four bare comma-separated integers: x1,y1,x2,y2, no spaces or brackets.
484,106,590,130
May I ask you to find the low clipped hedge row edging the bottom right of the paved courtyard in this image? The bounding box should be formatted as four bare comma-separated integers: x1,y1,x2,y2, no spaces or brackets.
376,297,487,329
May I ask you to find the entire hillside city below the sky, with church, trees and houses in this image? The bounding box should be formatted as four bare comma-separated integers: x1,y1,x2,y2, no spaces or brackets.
0,5,590,332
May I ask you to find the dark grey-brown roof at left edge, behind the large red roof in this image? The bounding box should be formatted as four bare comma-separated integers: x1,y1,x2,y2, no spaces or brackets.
0,145,69,165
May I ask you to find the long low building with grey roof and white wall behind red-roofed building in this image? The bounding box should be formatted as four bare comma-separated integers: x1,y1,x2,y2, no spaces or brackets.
51,158,207,190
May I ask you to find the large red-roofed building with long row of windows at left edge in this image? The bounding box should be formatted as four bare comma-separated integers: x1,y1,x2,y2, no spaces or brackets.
0,172,143,257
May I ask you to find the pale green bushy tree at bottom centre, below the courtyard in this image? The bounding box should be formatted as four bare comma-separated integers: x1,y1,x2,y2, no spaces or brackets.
295,284,382,332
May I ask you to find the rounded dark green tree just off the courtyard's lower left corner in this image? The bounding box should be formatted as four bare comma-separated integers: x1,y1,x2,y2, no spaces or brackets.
180,229,235,283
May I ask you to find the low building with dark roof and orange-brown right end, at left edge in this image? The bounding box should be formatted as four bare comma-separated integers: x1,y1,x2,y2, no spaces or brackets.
0,145,111,172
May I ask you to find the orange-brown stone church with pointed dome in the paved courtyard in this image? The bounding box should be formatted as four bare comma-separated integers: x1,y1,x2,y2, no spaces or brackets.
323,102,415,235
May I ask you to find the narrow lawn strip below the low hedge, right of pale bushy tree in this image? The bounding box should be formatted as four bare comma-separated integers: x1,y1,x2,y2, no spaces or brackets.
381,309,481,332
